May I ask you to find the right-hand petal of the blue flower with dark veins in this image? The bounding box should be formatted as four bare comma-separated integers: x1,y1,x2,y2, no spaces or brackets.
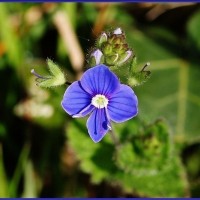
108,84,138,122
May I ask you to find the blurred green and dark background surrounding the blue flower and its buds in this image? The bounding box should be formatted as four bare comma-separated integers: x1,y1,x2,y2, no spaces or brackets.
0,3,200,197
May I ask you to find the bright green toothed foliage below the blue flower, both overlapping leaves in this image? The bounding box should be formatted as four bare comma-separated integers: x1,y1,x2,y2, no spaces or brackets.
67,120,187,197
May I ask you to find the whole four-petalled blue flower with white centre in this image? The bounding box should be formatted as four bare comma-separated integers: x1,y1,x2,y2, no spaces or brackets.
61,64,138,142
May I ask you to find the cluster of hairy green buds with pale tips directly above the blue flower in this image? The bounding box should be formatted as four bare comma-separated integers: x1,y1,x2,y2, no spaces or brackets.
87,28,151,87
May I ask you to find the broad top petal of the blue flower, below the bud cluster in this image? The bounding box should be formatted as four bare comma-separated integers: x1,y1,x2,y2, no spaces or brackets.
80,65,120,97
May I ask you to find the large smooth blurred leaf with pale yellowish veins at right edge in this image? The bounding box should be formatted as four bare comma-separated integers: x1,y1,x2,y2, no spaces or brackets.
127,27,200,144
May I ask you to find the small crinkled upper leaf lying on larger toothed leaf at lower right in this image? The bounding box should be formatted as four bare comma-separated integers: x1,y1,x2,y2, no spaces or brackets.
116,120,173,176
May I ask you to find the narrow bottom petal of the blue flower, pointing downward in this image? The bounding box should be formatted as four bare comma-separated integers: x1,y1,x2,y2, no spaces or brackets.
87,108,109,142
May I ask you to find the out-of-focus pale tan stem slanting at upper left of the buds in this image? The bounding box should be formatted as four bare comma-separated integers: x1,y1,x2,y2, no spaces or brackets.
53,11,84,79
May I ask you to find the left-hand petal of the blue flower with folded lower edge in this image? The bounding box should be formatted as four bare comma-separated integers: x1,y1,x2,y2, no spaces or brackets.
61,81,94,117
